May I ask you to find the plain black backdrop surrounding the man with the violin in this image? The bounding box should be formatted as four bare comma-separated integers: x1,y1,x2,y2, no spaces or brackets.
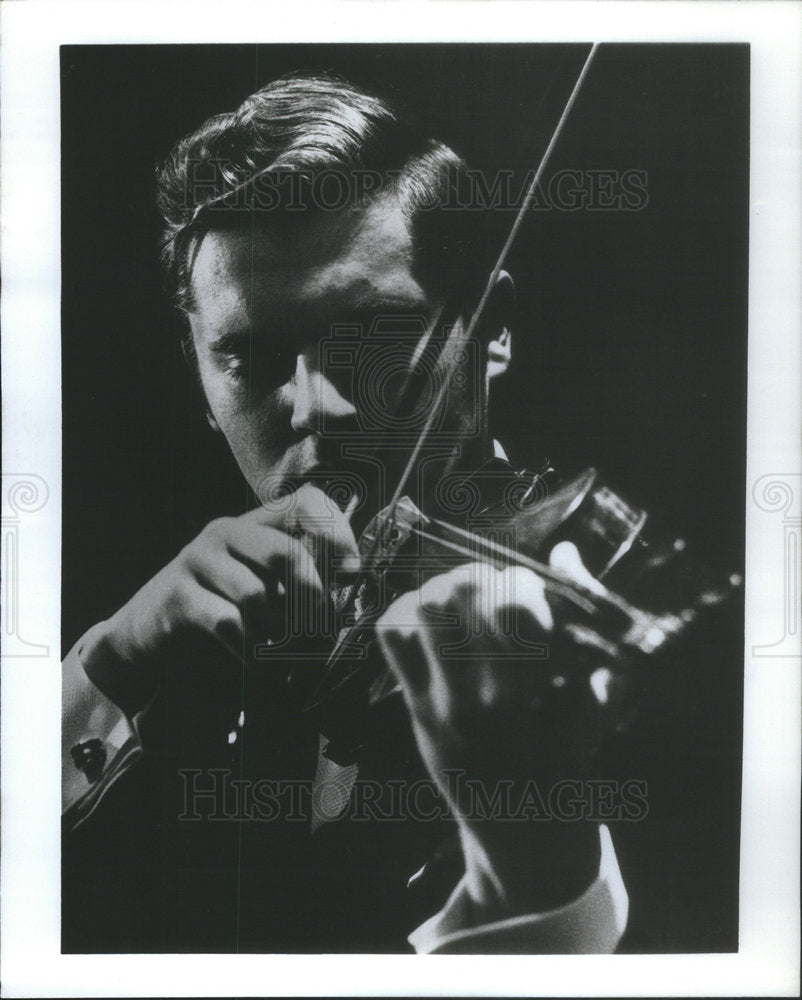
62,45,749,951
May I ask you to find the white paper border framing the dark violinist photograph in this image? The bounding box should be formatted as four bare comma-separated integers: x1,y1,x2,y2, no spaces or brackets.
0,0,802,997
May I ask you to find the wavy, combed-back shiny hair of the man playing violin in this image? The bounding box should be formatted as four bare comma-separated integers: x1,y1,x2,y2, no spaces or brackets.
157,74,489,314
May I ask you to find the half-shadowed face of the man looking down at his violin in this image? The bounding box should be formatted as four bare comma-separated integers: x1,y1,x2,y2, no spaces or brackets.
189,196,482,520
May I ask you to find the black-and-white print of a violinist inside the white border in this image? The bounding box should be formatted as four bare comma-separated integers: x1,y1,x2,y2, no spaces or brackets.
4,4,799,995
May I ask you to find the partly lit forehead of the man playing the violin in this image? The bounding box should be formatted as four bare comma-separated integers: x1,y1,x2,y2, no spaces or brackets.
190,197,430,334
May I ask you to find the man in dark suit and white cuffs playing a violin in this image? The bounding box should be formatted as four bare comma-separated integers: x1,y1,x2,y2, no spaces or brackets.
63,68,628,953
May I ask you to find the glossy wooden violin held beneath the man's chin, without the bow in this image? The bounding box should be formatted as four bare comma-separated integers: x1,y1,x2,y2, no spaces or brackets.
308,461,740,764
